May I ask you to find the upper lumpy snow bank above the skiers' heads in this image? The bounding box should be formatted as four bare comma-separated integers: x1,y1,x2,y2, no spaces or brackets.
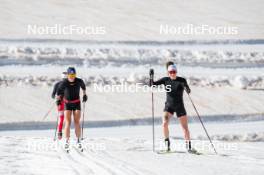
0,46,264,67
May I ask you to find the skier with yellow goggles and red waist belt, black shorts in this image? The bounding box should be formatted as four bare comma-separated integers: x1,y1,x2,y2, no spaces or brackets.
57,67,87,150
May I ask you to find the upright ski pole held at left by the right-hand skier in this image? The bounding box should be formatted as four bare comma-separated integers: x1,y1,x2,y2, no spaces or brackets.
149,69,155,152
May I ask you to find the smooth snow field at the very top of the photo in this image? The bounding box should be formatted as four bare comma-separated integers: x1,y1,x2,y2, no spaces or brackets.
0,0,264,41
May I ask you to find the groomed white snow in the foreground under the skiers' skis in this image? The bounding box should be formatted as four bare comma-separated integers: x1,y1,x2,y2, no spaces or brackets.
0,121,264,175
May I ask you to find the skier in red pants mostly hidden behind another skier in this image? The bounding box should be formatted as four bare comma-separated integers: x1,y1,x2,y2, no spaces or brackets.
51,72,67,140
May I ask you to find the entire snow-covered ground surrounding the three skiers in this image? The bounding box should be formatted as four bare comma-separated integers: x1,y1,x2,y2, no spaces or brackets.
0,0,264,175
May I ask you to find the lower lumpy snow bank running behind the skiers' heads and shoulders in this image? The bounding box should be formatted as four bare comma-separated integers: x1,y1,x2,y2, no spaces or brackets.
0,73,264,89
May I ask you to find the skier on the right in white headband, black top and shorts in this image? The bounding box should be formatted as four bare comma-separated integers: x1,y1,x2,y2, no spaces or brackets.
152,62,192,152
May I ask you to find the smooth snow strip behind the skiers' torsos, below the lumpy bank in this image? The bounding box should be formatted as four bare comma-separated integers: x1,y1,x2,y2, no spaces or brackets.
0,86,264,123
